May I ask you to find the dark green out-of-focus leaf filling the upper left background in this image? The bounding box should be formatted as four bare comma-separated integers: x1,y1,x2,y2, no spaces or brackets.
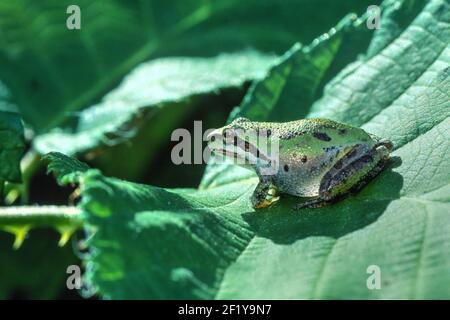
0,0,371,132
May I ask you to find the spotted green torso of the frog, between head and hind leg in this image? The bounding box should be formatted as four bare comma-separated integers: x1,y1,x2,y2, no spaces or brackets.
268,119,372,197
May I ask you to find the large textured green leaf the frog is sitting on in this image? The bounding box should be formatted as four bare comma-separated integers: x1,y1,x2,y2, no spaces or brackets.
44,0,450,299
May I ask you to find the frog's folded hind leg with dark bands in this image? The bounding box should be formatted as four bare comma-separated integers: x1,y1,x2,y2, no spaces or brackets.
319,145,388,202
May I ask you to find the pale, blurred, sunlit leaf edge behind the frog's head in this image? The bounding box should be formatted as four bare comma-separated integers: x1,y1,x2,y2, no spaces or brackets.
34,51,276,155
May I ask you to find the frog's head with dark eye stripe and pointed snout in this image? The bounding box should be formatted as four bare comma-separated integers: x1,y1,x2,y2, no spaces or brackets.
207,118,270,166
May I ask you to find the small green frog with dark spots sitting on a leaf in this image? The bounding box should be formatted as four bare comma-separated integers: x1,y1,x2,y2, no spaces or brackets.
206,117,393,209
